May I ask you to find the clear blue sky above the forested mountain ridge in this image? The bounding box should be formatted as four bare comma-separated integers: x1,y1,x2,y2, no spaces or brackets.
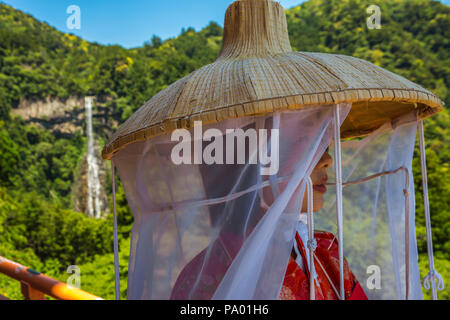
0,0,450,48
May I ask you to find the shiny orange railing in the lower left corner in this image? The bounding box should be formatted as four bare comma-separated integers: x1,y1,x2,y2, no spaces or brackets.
0,256,103,300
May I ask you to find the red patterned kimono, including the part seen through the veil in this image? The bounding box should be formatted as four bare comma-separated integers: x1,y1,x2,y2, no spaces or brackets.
171,231,367,300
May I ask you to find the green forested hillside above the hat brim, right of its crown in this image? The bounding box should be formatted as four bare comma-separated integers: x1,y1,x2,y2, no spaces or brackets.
288,0,450,105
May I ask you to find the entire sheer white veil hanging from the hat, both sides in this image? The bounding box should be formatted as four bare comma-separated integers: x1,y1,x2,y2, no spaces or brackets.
114,104,420,300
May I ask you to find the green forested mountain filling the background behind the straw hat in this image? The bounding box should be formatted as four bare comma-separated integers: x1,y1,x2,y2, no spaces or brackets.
0,0,450,299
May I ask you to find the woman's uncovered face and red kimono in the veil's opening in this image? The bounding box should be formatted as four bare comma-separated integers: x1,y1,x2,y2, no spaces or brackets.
280,151,367,300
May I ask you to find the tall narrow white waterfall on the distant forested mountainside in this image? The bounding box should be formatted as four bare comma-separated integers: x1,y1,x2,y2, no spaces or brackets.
85,97,101,218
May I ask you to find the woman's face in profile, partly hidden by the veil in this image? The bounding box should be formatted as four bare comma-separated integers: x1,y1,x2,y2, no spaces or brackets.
302,150,333,212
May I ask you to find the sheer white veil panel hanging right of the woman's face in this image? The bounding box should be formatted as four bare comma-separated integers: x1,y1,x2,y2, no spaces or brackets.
315,114,423,300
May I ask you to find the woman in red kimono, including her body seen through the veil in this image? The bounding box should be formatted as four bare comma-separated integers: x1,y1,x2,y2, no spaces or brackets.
171,151,367,300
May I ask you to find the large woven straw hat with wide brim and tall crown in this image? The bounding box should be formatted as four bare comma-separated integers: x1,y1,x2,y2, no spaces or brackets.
103,0,443,159
